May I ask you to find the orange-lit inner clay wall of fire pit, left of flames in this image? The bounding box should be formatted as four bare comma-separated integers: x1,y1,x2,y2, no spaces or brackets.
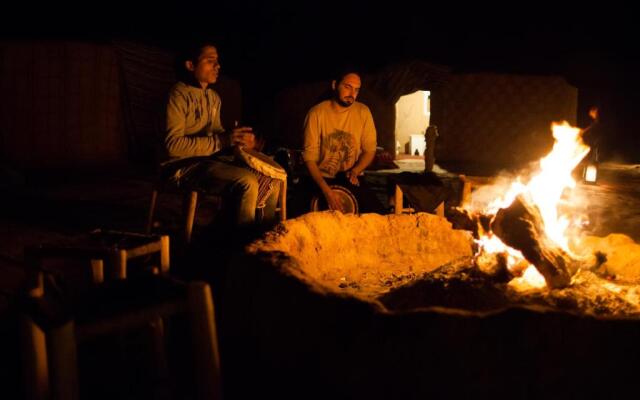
248,212,473,301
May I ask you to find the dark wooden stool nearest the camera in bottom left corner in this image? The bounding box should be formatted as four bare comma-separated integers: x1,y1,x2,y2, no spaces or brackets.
20,273,222,400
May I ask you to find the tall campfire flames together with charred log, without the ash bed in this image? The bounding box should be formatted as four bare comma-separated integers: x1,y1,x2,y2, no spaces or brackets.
467,122,594,288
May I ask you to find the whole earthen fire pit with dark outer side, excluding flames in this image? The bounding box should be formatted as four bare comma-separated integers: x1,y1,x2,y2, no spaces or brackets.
221,212,640,399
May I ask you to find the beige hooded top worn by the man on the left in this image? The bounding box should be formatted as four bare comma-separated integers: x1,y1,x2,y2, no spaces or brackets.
165,82,224,159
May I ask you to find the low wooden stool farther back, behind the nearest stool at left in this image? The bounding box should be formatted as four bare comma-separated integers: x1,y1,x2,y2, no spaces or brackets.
25,229,169,283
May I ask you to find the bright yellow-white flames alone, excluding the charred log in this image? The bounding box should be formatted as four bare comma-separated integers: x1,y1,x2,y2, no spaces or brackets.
470,121,589,289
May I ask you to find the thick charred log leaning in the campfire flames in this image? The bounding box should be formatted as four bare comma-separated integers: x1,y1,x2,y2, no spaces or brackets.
491,196,578,289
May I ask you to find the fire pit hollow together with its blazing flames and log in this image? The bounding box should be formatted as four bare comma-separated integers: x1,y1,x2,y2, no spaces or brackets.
248,122,640,317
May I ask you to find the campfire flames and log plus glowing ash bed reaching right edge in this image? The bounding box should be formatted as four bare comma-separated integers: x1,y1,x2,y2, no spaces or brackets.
456,122,639,315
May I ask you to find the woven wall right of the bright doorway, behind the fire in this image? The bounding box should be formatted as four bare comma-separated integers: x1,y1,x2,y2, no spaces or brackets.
431,74,578,168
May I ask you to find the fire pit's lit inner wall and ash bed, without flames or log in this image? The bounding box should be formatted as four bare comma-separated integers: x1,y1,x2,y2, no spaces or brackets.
241,212,640,318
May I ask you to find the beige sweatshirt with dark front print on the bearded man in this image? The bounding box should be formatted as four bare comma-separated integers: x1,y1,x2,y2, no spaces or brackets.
302,100,376,178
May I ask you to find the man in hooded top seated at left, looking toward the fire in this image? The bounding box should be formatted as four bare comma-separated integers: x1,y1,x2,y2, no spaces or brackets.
163,43,278,238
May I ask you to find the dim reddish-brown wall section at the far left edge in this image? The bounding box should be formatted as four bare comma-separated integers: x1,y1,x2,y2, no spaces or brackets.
0,41,126,167
